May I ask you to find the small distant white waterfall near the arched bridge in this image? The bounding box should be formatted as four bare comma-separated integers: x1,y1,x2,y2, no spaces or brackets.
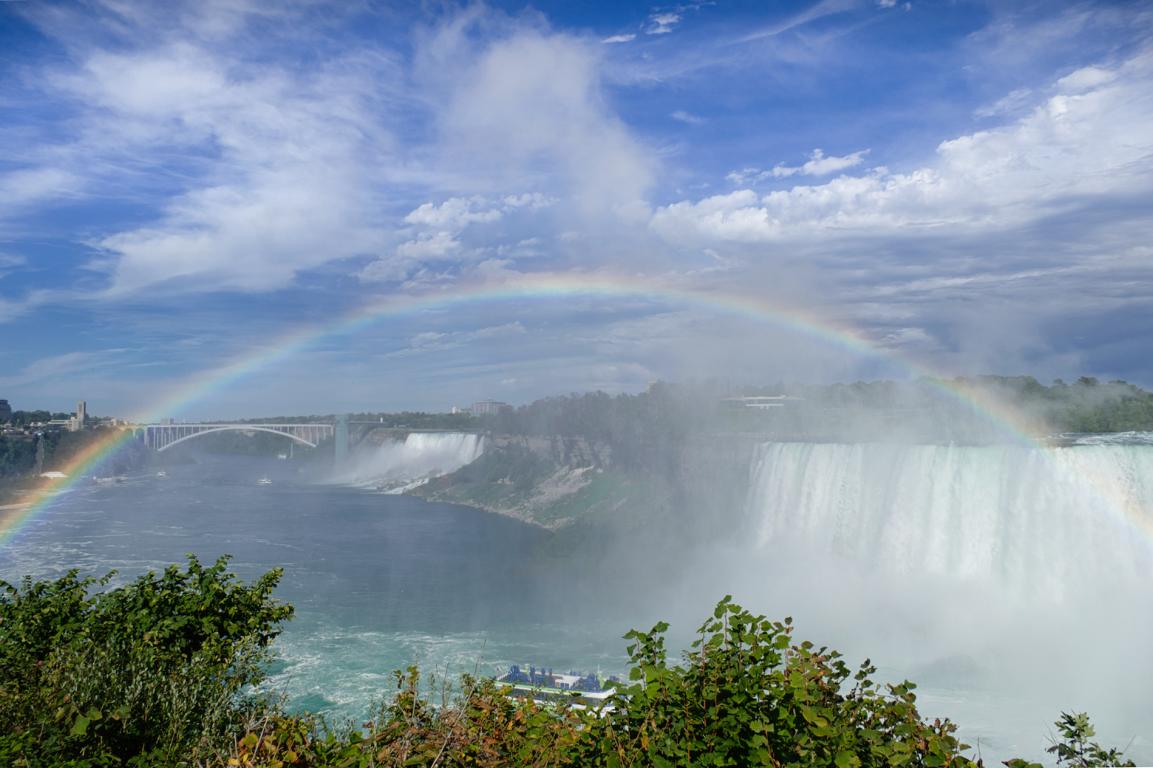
336,432,484,491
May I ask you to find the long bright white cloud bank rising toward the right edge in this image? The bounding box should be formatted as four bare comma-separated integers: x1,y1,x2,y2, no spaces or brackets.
653,54,1153,242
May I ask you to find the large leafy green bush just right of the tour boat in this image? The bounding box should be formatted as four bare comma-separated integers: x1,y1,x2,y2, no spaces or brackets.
578,597,974,768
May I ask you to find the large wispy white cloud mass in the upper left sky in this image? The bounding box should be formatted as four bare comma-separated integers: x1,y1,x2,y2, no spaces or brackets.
11,20,398,296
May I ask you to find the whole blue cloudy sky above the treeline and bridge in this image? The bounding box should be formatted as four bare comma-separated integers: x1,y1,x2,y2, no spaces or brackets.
0,0,1153,417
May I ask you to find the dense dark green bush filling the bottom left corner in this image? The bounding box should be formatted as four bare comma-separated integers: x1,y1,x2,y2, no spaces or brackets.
0,557,292,767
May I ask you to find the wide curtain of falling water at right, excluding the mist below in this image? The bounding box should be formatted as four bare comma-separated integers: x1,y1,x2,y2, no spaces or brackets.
749,435,1153,600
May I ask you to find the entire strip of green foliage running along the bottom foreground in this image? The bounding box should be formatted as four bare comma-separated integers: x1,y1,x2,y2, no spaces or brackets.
0,558,1132,768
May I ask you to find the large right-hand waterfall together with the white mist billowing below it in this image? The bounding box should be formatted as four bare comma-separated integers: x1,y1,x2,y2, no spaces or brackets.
737,436,1153,762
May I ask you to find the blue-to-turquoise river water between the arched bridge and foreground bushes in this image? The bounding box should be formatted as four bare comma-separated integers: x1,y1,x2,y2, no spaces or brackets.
0,457,628,720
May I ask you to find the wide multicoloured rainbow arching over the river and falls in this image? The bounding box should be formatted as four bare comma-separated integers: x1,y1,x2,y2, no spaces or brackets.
0,272,1134,547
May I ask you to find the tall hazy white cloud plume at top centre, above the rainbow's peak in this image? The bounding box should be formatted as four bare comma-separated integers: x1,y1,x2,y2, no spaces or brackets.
433,27,655,218
